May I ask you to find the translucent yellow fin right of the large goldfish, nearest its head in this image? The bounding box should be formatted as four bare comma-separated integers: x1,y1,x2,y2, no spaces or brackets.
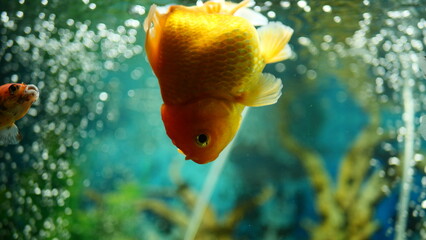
237,73,283,107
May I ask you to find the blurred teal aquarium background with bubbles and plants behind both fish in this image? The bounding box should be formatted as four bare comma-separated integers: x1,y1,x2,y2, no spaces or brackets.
0,0,426,240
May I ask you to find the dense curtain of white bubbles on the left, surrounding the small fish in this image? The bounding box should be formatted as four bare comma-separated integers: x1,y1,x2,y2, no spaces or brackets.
0,0,142,239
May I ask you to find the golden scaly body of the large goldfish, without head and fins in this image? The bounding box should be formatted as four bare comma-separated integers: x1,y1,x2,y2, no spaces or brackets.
157,8,264,104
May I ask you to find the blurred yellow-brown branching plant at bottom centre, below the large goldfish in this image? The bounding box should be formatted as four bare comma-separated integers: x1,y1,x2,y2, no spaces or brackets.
138,160,274,239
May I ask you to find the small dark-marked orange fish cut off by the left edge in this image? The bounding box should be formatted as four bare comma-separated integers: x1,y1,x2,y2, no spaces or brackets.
0,83,39,145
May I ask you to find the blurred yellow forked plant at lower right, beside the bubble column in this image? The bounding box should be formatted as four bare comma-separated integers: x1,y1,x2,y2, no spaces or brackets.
281,82,392,239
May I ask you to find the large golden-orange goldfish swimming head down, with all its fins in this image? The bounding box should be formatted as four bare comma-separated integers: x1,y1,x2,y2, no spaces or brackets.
144,0,293,164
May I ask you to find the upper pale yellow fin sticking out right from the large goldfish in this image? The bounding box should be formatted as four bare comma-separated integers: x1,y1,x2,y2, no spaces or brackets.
257,22,293,63
